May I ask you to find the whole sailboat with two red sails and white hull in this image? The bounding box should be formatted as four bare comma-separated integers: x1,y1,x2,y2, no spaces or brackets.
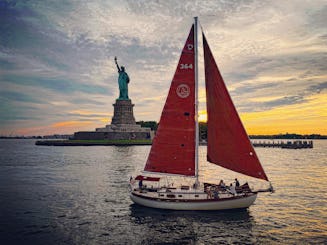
129,17,272,210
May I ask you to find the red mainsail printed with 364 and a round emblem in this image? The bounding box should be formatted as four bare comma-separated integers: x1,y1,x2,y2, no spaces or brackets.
144,26,195,176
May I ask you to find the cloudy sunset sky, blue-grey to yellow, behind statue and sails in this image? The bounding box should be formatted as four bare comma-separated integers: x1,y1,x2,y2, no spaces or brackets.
0,0,327,136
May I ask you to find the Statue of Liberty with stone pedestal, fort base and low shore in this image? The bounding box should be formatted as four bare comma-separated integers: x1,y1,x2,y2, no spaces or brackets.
36,57,154,146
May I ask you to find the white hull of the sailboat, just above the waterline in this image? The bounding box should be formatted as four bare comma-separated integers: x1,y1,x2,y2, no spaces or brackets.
130,192,257,210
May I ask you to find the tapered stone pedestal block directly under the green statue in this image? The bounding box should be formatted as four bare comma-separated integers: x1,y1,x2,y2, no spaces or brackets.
111,99,136,125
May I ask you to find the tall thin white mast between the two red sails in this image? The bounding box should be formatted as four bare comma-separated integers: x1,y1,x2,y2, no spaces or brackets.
194,17,199,186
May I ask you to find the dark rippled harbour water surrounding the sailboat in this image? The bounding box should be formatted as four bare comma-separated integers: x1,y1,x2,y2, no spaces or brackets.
0,140,327,244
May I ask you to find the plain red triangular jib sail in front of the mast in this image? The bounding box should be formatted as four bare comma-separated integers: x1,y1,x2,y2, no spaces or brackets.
202,33,268,180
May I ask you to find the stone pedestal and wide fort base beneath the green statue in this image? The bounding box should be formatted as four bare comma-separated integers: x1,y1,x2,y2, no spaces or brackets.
74,99,154,140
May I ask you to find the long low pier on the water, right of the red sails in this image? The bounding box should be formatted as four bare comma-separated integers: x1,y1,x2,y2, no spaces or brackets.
252,140,313,149
